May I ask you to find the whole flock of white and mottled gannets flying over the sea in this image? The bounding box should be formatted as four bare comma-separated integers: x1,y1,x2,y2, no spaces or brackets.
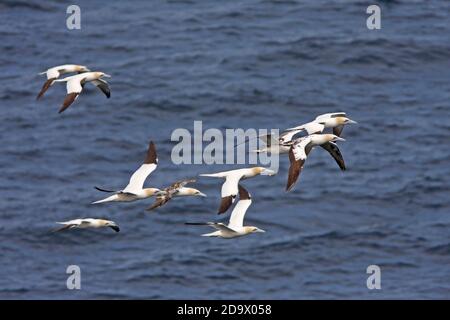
36,64,356,239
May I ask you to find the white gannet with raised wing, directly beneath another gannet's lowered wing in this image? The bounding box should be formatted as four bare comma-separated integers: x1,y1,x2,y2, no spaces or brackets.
186,185,265,239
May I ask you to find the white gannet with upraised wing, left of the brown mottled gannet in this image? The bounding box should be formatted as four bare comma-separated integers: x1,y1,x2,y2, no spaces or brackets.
92,141,161,204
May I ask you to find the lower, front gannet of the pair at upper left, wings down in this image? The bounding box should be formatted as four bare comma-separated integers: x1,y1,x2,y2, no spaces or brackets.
54,72,111,113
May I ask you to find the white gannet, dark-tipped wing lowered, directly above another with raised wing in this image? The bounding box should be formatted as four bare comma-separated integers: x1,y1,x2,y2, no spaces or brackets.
200,167,276,214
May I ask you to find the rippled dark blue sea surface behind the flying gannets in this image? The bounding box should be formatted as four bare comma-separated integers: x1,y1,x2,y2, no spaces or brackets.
0,0,450,299
